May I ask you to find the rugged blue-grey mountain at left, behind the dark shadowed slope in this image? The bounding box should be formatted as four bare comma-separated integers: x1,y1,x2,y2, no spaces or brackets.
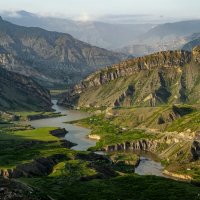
0,16,126,87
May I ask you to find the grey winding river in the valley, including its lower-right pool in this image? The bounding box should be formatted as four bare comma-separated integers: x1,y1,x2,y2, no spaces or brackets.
30,100,164,176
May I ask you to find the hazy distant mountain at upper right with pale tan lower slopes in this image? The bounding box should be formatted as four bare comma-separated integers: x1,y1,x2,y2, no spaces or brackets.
117,20,200,56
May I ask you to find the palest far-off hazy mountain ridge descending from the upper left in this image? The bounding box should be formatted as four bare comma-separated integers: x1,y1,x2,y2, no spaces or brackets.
2,11,153,49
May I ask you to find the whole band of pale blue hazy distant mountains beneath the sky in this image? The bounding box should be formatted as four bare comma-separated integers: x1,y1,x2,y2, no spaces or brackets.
2,11,200,56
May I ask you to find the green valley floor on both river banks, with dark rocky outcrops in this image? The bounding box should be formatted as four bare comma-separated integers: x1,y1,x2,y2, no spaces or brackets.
0,106,200,200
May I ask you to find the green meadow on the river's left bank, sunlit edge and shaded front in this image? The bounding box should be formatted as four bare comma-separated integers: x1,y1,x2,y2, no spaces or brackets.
0,126,69,169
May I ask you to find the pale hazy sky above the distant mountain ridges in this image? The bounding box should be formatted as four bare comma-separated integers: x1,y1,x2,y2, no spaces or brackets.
0,0,200,21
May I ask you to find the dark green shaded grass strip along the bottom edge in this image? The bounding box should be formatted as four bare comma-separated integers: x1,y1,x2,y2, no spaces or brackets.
23,174,199,200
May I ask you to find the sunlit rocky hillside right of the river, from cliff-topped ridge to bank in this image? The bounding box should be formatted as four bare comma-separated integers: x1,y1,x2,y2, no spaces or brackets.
60,46,200,180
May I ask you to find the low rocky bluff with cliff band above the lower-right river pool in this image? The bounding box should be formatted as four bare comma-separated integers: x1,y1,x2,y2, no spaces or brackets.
104,133,200,162
